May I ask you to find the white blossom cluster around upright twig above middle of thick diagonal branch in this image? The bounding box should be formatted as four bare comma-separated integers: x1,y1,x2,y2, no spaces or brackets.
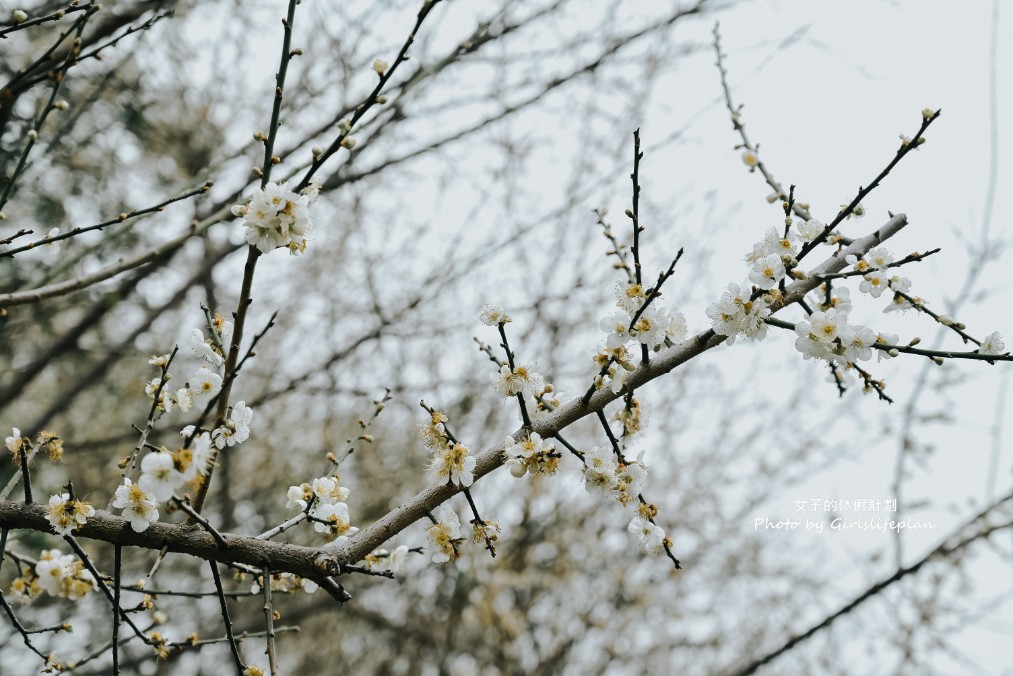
593,282,687,393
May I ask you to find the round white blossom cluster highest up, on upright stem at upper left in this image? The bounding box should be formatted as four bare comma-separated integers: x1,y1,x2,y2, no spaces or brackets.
232,181,320,255
